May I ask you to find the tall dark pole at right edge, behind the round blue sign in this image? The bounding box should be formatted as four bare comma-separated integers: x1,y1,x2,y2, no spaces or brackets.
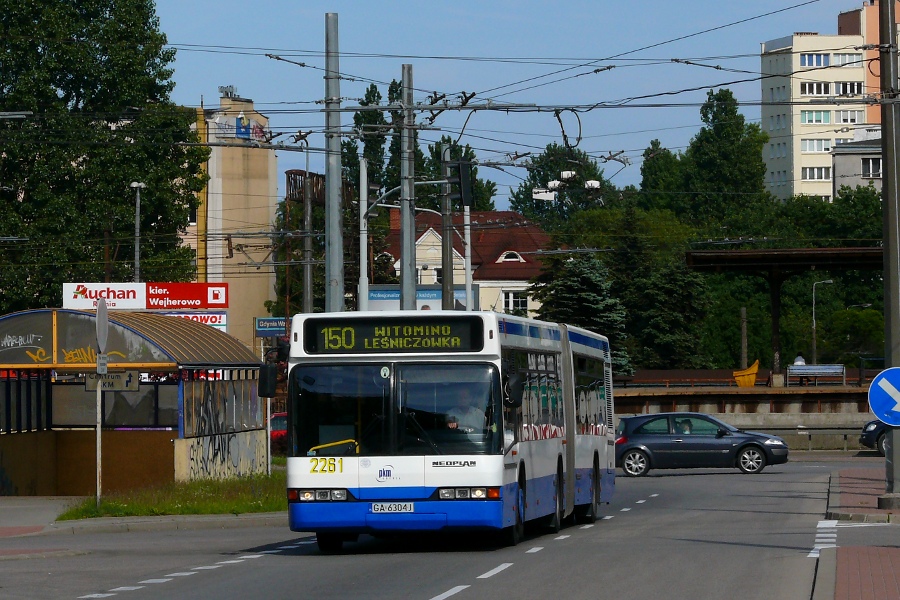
878,0,900,508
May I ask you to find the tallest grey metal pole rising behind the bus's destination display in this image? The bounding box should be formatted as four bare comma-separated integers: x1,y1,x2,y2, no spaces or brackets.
324,13,344,312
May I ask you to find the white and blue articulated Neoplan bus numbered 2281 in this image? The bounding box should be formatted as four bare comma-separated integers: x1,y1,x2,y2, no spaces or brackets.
287,311,615,553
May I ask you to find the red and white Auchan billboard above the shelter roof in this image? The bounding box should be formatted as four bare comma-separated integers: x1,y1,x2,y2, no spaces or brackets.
63,283,228,310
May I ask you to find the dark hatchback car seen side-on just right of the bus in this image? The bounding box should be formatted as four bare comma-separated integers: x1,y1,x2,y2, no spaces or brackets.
616,412,788,477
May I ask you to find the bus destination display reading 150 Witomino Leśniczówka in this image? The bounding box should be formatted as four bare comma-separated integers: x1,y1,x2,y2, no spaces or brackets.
303,315,484,354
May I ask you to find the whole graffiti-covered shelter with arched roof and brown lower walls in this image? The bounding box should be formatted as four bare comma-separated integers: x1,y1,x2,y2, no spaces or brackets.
0,309,269,496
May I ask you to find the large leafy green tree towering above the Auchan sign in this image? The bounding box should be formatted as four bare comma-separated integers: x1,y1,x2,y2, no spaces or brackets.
0,0,209,312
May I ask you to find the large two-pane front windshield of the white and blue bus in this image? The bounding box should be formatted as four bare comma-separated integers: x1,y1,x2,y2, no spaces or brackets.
289,363,503,456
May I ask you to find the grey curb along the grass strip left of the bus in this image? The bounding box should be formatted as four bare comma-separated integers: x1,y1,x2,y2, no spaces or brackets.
35,511,288,535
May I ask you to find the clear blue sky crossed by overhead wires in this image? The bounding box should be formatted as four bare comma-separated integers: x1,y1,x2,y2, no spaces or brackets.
156,0,863,210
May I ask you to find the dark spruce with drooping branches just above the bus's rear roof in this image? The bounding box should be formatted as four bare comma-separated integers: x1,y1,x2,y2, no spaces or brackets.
528,255,634,375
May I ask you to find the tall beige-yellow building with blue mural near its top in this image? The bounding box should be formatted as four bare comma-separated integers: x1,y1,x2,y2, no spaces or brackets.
193,86,278,348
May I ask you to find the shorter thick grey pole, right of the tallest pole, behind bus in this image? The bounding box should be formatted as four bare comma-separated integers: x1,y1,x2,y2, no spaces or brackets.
400,65,416,310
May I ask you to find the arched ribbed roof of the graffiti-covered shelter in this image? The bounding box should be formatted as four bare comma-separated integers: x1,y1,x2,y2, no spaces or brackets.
0,308,261,371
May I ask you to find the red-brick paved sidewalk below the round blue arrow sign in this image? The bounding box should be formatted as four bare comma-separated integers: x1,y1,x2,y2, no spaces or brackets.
813,466,900,600
